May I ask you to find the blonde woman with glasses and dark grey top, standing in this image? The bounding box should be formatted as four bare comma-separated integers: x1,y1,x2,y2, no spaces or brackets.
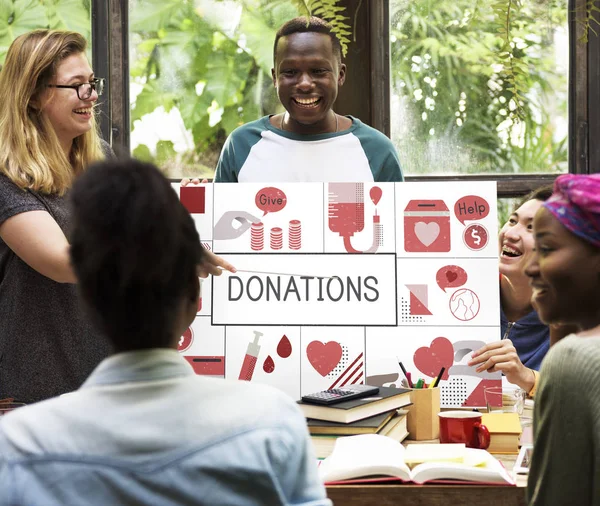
0,30,111,403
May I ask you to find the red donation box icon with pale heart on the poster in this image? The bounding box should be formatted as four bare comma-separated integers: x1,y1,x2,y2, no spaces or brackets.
404,200,450,253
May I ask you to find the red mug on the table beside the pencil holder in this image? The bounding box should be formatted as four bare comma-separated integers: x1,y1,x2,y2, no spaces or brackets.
438,411,490,450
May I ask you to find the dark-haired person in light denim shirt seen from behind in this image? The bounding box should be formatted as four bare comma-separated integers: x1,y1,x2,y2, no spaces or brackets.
0,160,331,506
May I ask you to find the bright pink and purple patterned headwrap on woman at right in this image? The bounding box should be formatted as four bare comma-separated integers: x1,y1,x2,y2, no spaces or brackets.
543,174,600,248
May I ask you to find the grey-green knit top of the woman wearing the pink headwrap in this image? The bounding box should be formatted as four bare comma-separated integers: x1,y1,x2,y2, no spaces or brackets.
527,335,600,506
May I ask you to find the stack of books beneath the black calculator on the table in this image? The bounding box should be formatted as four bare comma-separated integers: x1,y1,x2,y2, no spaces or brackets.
298,387,410,458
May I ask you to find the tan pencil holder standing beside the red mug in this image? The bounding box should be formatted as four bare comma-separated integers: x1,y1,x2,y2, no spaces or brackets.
406,387,440,441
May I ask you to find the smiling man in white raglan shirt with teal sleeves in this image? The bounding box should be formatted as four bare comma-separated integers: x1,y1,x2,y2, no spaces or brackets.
215,17,403,182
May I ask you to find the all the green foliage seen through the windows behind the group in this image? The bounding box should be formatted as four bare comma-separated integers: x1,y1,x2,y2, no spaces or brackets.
0,0,576,182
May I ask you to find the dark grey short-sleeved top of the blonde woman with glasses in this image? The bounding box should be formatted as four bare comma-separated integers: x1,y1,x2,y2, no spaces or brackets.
0,154,111,403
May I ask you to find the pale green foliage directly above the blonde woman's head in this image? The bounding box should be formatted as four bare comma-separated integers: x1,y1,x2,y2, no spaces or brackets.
0,0,91,64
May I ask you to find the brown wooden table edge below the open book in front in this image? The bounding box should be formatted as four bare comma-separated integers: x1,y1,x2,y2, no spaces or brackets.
327,455,527,506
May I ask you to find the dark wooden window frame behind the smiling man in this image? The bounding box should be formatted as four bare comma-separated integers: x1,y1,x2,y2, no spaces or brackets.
97,0,600,194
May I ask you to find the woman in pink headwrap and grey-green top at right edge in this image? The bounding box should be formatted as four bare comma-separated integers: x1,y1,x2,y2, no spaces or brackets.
525,174,600,506
